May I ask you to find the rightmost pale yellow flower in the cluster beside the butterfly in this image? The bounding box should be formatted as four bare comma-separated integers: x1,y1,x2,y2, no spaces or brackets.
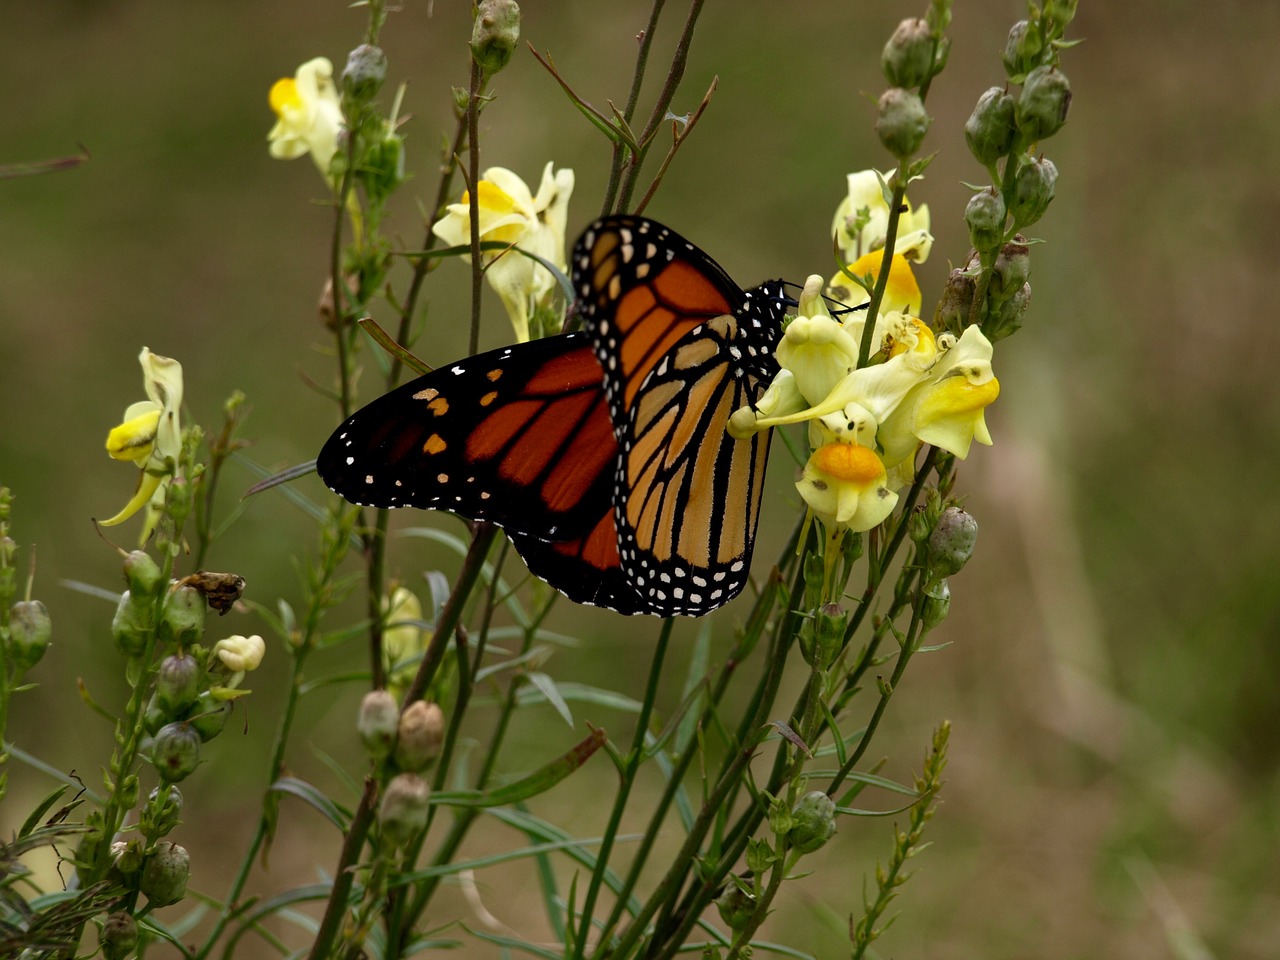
879,326,1000,466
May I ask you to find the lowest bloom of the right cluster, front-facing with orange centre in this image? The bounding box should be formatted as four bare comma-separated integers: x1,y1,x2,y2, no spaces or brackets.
796,442,897,531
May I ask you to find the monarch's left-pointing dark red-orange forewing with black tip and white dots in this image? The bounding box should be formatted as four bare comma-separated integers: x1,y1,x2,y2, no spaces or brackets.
316,333,617,539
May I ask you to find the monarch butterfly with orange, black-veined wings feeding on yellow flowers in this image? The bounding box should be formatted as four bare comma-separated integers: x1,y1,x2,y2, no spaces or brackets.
316,216,790,616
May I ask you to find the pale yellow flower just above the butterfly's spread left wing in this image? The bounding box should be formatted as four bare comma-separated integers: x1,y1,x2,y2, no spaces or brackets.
431,164,573,342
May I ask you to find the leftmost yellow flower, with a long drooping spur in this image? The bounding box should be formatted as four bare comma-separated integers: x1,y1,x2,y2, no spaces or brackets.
101,347,182,543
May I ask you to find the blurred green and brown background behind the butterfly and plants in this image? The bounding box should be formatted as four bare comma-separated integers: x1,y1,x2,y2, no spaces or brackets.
0,0,1280,960
